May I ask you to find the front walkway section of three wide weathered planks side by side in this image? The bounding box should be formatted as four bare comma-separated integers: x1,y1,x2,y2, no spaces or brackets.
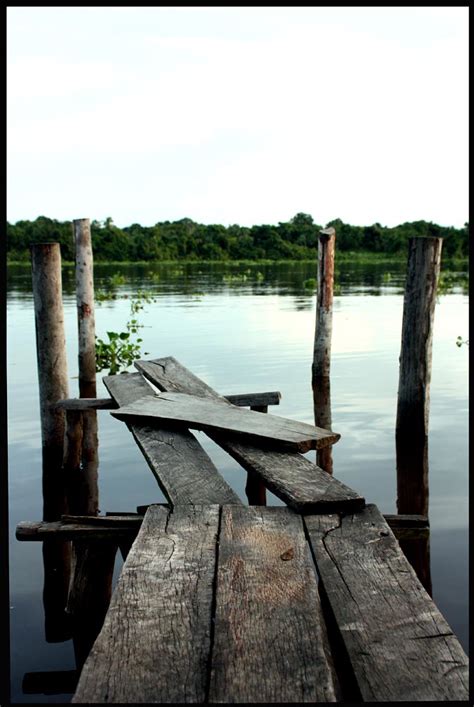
72,505,468,703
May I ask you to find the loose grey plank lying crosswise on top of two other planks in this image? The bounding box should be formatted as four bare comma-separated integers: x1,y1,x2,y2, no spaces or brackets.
110,393,340,452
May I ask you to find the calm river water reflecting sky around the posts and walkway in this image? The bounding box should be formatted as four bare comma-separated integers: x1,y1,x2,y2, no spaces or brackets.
7,263,469,703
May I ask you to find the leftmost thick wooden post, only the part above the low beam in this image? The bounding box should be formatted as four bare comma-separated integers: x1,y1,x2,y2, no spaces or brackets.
31,243,69,520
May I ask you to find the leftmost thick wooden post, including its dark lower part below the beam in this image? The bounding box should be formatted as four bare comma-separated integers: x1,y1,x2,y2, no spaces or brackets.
31,243,71,642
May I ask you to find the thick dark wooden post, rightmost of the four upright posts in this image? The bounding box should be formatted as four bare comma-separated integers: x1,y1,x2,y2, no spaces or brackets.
396,238,442,515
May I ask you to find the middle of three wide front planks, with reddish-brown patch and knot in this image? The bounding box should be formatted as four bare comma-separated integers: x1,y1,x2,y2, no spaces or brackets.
209,506,337,704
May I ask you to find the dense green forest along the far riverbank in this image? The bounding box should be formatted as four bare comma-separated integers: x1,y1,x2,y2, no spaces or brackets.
7,213,469,262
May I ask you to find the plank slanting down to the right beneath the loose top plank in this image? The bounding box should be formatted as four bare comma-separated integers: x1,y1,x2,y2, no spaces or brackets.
135,356,365,513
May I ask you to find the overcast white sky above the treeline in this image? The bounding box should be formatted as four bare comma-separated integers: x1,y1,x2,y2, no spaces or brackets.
7,7,468,227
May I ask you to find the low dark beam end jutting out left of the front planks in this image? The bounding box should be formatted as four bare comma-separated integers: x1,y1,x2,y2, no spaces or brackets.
15,516,141,542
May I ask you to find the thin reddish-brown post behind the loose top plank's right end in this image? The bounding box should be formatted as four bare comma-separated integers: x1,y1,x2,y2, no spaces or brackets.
312,226,336,474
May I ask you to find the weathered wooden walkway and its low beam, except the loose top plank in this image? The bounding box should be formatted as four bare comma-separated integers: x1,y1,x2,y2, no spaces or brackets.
17,358,469,703
